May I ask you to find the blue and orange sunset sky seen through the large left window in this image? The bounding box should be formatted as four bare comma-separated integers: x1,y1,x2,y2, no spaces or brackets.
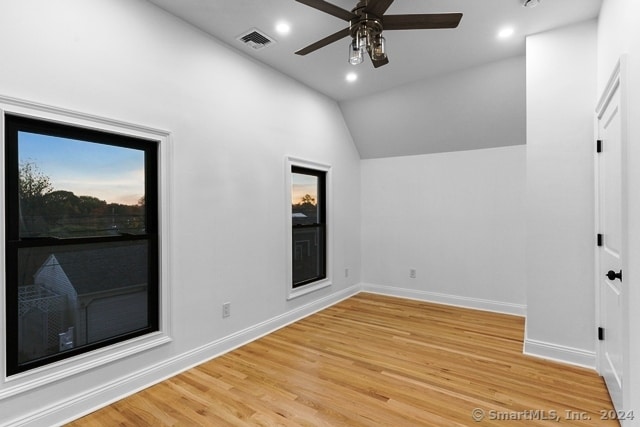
18,132,144,205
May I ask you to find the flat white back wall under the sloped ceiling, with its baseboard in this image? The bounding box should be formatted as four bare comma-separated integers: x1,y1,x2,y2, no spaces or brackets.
361,145,526,315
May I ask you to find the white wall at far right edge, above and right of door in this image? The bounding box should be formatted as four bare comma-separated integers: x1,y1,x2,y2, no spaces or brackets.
598,0,640,427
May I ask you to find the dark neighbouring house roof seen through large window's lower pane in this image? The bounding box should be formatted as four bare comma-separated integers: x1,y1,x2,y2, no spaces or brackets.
54,242,148,295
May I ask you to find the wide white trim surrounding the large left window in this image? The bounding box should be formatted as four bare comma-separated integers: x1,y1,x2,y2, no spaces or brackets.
0,96,172,401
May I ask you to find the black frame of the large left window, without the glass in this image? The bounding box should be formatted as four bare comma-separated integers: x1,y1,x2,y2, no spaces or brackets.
4,113,160,376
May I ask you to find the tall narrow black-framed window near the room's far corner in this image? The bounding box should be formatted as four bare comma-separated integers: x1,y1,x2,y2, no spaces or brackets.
291,166,327,288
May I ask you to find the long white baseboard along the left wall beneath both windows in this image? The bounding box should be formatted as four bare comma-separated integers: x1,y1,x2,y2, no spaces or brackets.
7,284,360,427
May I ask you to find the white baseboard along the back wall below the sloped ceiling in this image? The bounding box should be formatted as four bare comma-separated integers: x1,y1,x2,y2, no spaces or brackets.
362,283,527,317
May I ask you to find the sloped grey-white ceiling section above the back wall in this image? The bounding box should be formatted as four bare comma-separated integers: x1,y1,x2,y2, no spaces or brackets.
340,56,526,159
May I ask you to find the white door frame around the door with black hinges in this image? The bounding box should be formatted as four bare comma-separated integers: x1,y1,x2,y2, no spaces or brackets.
594,55,631,411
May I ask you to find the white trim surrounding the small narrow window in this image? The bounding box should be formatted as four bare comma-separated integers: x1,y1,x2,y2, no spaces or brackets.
285,157,333,300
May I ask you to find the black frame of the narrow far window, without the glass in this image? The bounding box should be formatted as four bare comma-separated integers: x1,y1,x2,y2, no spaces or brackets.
290,165,327,289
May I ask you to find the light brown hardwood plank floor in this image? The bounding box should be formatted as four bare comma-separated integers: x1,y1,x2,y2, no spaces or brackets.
70,293,619,427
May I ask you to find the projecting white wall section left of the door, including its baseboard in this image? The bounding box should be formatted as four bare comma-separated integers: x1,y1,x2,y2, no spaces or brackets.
525,21,596,366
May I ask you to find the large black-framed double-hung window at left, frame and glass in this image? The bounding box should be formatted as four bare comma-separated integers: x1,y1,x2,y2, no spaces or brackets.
5,114,159,375
